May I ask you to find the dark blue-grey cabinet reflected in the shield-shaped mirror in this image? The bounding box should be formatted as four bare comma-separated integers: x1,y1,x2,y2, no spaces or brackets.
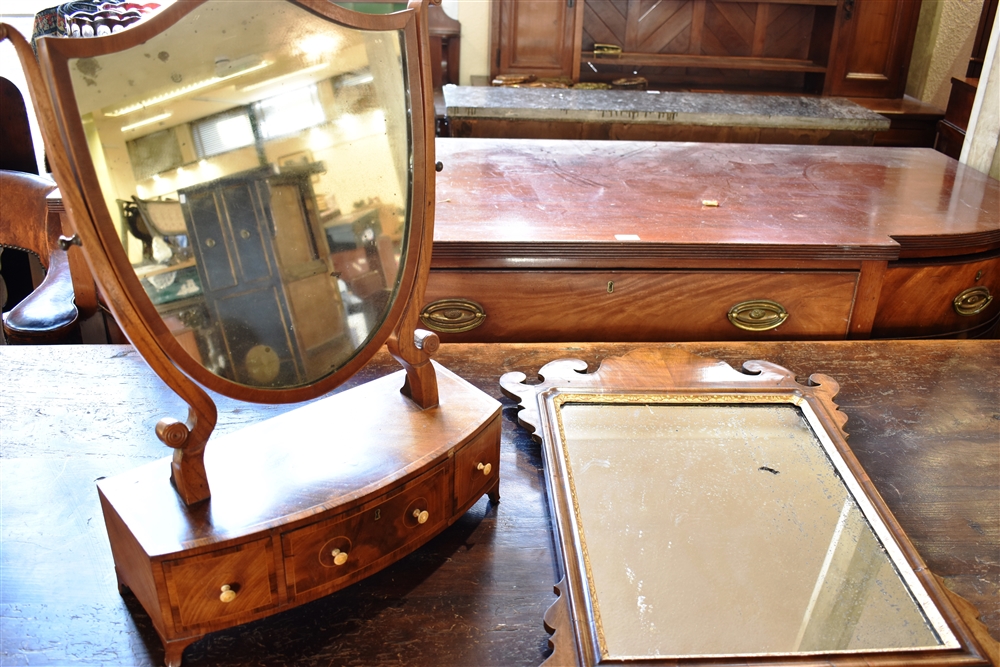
178,168,354,386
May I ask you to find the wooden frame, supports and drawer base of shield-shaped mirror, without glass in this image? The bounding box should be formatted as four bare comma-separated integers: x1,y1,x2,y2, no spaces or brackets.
0,0,500,667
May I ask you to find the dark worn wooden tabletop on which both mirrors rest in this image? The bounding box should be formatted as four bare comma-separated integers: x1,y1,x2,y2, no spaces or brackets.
0,341,1000,667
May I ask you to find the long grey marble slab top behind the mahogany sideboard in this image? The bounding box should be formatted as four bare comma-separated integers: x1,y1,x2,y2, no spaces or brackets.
444,85,889,132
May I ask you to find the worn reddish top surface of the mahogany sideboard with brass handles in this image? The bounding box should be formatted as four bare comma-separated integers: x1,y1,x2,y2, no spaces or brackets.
434,138,1000,268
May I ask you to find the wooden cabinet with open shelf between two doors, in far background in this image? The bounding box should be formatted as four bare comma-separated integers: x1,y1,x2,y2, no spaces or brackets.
490,0,920,98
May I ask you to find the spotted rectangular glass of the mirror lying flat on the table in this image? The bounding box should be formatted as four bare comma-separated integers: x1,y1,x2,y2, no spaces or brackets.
555,394,957,660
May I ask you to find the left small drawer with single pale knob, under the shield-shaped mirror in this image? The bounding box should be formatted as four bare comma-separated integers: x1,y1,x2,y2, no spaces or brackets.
163,539,278,632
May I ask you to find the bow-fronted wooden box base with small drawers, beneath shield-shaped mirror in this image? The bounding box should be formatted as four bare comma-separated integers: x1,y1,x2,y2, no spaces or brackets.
98,366,500,667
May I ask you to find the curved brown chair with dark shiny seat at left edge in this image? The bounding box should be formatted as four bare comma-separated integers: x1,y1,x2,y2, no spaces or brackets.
0,170,80,344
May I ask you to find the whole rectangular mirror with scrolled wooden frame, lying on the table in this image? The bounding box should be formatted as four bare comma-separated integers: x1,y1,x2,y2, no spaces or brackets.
501,348,998,667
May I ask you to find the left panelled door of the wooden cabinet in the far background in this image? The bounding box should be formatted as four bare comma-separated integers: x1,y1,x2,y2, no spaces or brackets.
490,0,583,78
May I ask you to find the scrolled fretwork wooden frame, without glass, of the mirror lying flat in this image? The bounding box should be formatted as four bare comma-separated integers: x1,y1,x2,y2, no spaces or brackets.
500,348,998,667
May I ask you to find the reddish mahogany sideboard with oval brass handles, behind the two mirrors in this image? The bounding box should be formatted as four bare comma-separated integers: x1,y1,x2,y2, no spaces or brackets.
423,139,1000,342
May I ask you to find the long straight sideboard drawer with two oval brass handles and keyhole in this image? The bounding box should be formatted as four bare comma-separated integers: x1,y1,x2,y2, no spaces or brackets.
421,270,859,342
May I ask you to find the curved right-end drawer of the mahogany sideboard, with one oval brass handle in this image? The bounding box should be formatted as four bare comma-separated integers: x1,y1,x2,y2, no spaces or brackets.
872,257,1000,337
